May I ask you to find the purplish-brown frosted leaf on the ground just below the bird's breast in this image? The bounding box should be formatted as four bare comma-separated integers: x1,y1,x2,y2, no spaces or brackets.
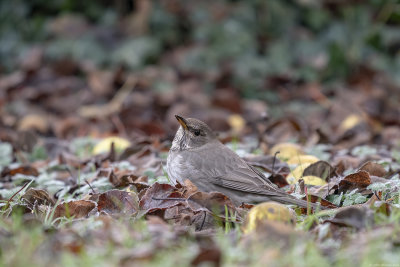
139,183,184,213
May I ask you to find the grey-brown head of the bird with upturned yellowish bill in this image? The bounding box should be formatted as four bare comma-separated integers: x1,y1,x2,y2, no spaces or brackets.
171,115,216,150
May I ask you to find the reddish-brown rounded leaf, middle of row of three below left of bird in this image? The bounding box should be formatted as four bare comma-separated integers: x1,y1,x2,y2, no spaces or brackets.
97,189,139,215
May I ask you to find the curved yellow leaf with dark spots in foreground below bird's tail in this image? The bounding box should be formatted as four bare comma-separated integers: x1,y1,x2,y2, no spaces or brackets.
242,202,296,234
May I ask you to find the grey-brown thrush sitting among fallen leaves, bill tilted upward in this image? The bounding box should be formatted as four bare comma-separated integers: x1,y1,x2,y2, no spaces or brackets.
167,115,316,208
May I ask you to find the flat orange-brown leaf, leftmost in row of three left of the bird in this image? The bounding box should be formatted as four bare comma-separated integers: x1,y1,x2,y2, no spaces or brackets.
54,200,97,219
